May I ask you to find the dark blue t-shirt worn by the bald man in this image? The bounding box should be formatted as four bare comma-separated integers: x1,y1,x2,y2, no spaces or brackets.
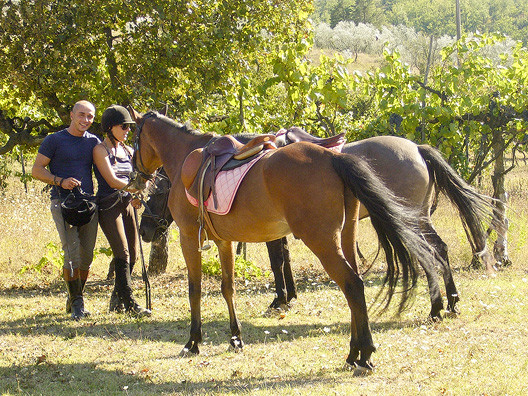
38,129,100,199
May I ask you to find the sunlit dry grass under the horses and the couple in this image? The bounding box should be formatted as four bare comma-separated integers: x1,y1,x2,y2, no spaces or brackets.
0,162,528,395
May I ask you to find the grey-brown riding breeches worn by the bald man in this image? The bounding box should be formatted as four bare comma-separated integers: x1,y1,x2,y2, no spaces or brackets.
50,199,97,273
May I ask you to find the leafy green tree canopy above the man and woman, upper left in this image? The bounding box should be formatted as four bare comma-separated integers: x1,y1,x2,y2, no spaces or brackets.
0,0,313,133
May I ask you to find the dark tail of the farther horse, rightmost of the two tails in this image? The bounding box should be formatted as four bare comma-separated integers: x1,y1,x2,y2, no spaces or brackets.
418,144,493,255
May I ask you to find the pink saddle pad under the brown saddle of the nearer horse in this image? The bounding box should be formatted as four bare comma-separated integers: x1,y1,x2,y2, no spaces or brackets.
185,150,268,215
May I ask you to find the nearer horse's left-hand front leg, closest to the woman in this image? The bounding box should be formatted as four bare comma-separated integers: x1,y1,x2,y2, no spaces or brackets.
180,234,202,356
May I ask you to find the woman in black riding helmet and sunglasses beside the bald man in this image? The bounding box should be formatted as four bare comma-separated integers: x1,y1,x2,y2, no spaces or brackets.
93,105,151,317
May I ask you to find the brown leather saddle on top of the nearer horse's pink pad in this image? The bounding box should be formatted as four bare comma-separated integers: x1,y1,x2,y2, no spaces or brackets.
181,134,276,207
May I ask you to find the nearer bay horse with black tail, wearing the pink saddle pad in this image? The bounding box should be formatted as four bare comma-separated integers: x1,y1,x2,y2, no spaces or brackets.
130,109,434,374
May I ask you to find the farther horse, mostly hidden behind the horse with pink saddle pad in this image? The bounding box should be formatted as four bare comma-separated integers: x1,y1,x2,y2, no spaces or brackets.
140,135,493,320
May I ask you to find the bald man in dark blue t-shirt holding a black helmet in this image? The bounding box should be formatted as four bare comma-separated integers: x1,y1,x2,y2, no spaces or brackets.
32,100,100,320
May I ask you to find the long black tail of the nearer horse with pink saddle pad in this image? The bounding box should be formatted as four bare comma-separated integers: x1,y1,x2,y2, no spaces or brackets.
332,153,433,312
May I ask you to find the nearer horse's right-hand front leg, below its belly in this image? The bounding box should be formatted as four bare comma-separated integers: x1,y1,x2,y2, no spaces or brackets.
216,241,244,352
